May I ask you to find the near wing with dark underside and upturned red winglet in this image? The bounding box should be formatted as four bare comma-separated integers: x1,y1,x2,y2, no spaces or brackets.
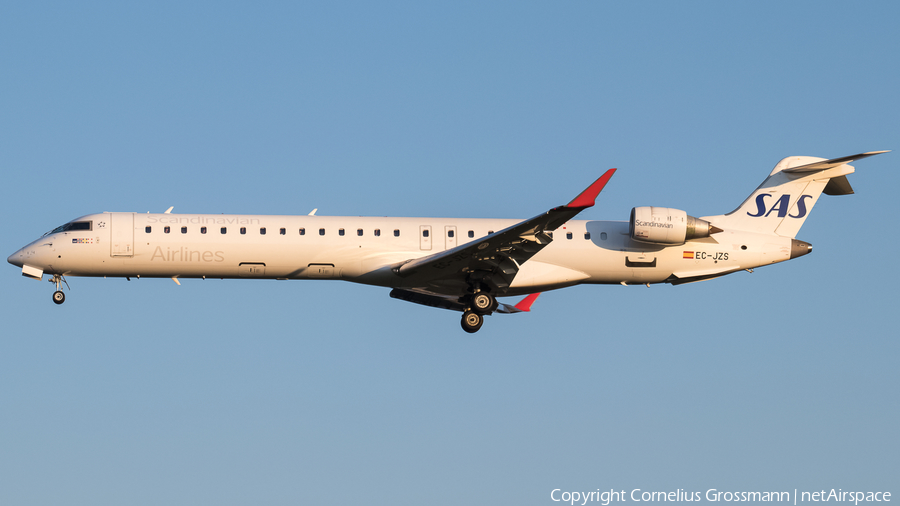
393,169,616,291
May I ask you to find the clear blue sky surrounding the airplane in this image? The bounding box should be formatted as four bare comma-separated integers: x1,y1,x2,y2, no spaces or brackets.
0,1,900,505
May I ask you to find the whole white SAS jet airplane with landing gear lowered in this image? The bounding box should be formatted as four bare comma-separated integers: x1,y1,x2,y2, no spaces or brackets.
7,151,887,333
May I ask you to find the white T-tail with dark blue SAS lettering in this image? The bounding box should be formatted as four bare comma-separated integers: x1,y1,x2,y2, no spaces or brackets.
702,151,887,239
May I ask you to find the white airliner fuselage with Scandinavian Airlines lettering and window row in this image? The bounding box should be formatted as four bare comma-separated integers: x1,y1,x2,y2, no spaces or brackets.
9,213,791,295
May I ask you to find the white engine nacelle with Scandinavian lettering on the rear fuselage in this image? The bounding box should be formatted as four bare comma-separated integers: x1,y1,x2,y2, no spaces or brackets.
628,206,721,245
